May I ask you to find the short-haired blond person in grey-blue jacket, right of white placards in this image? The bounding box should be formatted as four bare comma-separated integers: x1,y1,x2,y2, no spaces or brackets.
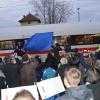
56,66,94,100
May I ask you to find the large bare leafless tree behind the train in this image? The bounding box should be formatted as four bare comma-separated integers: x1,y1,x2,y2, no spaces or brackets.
32,0,72,24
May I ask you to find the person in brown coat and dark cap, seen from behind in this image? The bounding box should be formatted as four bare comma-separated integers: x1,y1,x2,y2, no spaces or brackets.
21,54,37,86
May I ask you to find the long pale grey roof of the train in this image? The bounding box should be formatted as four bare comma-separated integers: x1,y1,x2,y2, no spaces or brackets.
0,22,100,40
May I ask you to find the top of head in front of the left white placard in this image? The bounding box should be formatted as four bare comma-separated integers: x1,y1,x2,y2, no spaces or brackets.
12,90,35,100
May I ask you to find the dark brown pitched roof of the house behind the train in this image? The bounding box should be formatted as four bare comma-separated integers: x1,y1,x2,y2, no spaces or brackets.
19,13,41,23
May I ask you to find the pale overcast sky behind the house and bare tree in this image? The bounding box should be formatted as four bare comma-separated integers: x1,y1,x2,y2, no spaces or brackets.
0,0,100,28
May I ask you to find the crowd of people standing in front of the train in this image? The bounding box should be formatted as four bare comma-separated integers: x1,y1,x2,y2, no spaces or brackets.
0,43,100,100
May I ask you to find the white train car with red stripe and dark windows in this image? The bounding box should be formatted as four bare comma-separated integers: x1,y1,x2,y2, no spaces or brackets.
0,22,100,57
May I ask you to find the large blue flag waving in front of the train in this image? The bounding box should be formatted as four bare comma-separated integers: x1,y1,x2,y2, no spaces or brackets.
23,32,53,51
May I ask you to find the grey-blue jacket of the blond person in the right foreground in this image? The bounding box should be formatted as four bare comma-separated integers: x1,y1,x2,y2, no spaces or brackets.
56,85,94,100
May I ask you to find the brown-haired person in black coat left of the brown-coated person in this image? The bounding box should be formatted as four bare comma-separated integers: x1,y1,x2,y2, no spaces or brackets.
2,56,21,88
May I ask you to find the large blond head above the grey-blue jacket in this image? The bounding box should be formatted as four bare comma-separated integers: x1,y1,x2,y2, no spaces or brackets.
64,67,81,88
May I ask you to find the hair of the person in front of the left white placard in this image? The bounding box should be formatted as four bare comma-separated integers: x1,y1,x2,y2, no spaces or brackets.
12,89,35,100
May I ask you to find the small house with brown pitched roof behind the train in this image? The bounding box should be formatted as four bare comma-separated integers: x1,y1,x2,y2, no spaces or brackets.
19,13,41,26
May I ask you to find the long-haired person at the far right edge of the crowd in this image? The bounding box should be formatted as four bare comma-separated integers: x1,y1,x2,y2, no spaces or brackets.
86,52,100,100
